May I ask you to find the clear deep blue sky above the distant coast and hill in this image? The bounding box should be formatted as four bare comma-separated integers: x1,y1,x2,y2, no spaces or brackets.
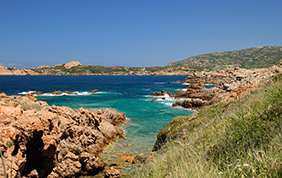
0,0,282,68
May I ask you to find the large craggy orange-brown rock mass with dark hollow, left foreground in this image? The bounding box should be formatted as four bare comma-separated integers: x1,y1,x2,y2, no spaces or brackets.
0,93,126,178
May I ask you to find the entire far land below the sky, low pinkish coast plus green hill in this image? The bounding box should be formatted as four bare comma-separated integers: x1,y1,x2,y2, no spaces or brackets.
0,46,282,75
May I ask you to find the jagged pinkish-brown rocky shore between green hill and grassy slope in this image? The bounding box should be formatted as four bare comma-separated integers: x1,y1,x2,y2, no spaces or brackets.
152,61,282,110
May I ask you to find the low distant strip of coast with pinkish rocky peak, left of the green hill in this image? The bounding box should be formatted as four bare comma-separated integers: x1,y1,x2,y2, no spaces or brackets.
0,61,190,75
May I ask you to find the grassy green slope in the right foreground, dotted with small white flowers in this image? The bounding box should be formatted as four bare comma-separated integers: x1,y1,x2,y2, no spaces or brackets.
126,76,282,177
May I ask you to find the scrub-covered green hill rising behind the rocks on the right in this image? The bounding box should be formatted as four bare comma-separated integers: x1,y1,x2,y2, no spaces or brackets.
167,46,282,70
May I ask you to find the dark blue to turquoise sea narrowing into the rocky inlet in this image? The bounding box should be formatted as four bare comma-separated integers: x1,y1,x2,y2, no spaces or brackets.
0,76,203,155
